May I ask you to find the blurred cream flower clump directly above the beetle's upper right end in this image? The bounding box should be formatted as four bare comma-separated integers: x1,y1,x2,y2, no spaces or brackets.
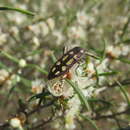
68,26,86,39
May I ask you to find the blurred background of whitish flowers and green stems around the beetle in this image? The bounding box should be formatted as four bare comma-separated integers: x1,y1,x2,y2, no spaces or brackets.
0,0,130,130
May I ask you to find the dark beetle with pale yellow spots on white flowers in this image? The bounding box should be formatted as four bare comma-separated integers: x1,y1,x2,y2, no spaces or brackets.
48,47,84,80
